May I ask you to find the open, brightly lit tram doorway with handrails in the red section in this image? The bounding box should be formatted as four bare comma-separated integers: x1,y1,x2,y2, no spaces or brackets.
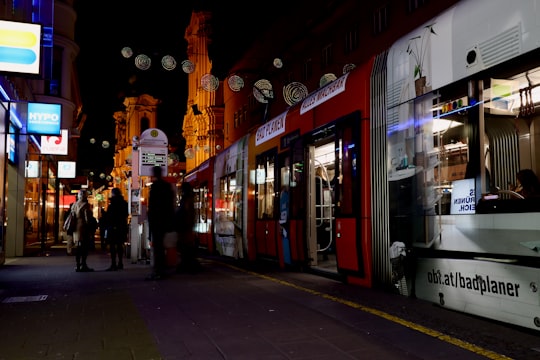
306,138,340,272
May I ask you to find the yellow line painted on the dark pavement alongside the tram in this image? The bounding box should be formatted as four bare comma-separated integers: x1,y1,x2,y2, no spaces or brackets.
221,263,511,360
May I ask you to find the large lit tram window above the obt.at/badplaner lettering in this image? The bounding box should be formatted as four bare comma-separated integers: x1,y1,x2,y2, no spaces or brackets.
430,70,539,215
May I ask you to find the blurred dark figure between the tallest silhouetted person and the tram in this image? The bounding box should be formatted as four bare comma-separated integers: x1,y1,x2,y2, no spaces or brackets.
174,182,201,273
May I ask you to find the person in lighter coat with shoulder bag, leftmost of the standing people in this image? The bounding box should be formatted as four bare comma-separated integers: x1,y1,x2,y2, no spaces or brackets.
72,190,94,272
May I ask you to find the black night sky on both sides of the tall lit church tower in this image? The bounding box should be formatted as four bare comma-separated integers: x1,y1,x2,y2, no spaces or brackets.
74,0,294,171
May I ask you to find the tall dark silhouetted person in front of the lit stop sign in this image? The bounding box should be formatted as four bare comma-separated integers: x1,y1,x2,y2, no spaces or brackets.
147,166,175,280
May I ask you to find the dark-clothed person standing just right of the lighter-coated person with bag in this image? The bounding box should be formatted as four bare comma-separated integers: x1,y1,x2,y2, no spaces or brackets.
105,188,129,271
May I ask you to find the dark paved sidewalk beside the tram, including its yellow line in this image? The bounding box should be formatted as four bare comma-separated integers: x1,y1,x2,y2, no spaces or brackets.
0,251,540,360
